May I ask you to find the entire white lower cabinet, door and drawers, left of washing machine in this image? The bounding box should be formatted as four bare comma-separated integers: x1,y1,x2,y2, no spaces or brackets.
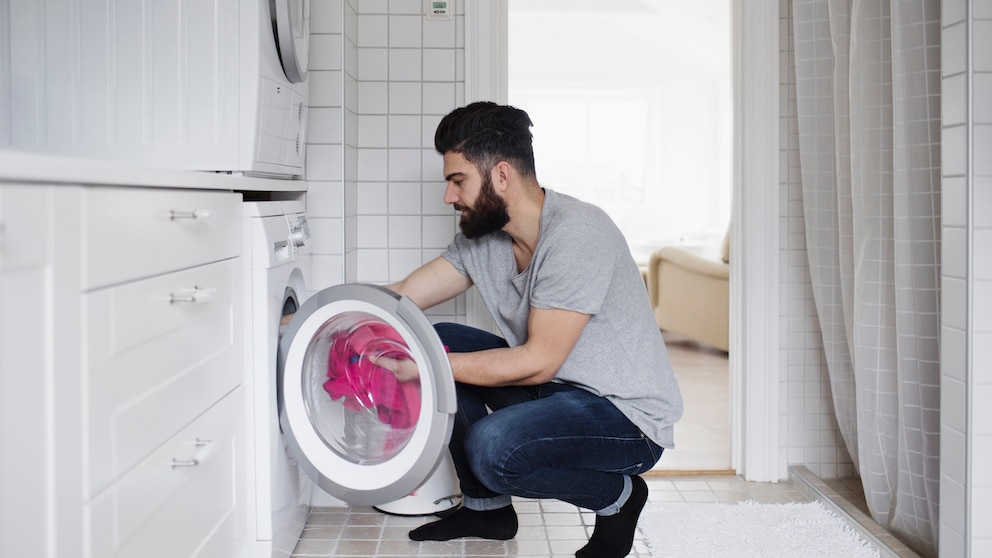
0,184,246,558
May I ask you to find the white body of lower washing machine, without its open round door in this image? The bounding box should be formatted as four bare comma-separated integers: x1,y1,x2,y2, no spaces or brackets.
244,200,313,558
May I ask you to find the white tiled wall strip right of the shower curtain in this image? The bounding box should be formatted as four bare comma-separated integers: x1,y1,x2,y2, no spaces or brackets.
940,0,992,556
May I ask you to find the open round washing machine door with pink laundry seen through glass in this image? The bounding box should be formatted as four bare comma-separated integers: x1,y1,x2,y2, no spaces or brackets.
278,284,456,505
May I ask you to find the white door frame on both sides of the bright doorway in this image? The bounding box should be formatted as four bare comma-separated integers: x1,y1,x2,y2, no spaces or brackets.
464,0,788,482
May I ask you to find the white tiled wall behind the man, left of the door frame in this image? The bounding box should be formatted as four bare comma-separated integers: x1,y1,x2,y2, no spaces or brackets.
307,0,465,321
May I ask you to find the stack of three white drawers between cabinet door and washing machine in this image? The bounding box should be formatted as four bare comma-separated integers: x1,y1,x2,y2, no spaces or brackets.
80,188,243,558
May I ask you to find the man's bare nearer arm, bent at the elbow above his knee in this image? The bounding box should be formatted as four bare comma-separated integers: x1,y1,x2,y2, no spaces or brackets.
449,308,590,386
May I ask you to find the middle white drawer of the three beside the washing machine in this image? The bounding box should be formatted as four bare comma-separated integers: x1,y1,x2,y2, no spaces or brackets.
84,258,241,496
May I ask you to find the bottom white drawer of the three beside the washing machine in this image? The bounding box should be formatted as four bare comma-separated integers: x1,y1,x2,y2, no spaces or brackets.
86,390,241,558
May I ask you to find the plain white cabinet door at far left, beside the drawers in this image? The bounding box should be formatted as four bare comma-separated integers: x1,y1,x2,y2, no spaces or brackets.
0,185,54,556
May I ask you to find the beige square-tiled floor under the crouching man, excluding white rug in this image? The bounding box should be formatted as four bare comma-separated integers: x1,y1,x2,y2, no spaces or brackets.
293,473,808,558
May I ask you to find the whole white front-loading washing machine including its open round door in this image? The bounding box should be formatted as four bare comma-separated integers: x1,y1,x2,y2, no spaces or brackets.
244,200,461,558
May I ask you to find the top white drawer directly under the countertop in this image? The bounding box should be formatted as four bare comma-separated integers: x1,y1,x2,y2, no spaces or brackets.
82,188,242,291
